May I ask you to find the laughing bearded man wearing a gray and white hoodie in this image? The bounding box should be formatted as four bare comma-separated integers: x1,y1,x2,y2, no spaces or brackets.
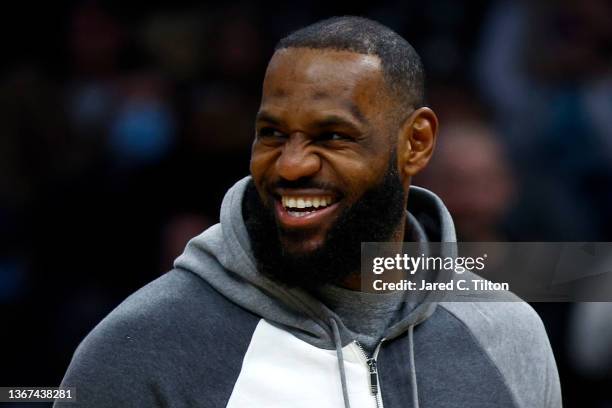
55,17,560,408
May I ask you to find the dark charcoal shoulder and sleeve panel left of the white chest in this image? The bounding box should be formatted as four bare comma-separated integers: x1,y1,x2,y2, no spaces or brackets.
55,270,259,407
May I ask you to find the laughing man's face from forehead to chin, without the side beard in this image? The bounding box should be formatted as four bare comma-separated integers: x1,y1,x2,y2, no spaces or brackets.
251,48,403,257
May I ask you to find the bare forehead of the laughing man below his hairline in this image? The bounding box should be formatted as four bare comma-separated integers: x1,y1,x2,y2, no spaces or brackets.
262,48,384,114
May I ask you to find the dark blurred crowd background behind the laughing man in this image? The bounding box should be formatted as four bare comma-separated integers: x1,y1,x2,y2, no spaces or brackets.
0,0,612,408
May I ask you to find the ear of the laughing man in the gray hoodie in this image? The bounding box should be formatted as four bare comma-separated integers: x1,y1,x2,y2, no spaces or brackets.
397,107,438,186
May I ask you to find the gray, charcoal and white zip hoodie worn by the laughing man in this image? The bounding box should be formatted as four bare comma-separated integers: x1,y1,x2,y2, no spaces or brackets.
56,177,561,408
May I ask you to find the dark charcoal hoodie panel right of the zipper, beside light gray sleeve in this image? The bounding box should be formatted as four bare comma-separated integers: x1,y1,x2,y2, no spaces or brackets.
378,307,517,408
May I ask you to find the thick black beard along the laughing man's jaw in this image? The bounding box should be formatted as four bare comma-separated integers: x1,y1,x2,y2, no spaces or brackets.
242,154,404,290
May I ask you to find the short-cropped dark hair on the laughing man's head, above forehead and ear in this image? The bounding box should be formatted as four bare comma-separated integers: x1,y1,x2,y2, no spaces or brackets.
275,16,425,115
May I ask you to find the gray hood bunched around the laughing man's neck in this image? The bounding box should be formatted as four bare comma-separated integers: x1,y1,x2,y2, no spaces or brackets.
174,176,456,349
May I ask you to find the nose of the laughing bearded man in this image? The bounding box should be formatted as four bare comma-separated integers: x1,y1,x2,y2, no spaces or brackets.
276,135,321,181
